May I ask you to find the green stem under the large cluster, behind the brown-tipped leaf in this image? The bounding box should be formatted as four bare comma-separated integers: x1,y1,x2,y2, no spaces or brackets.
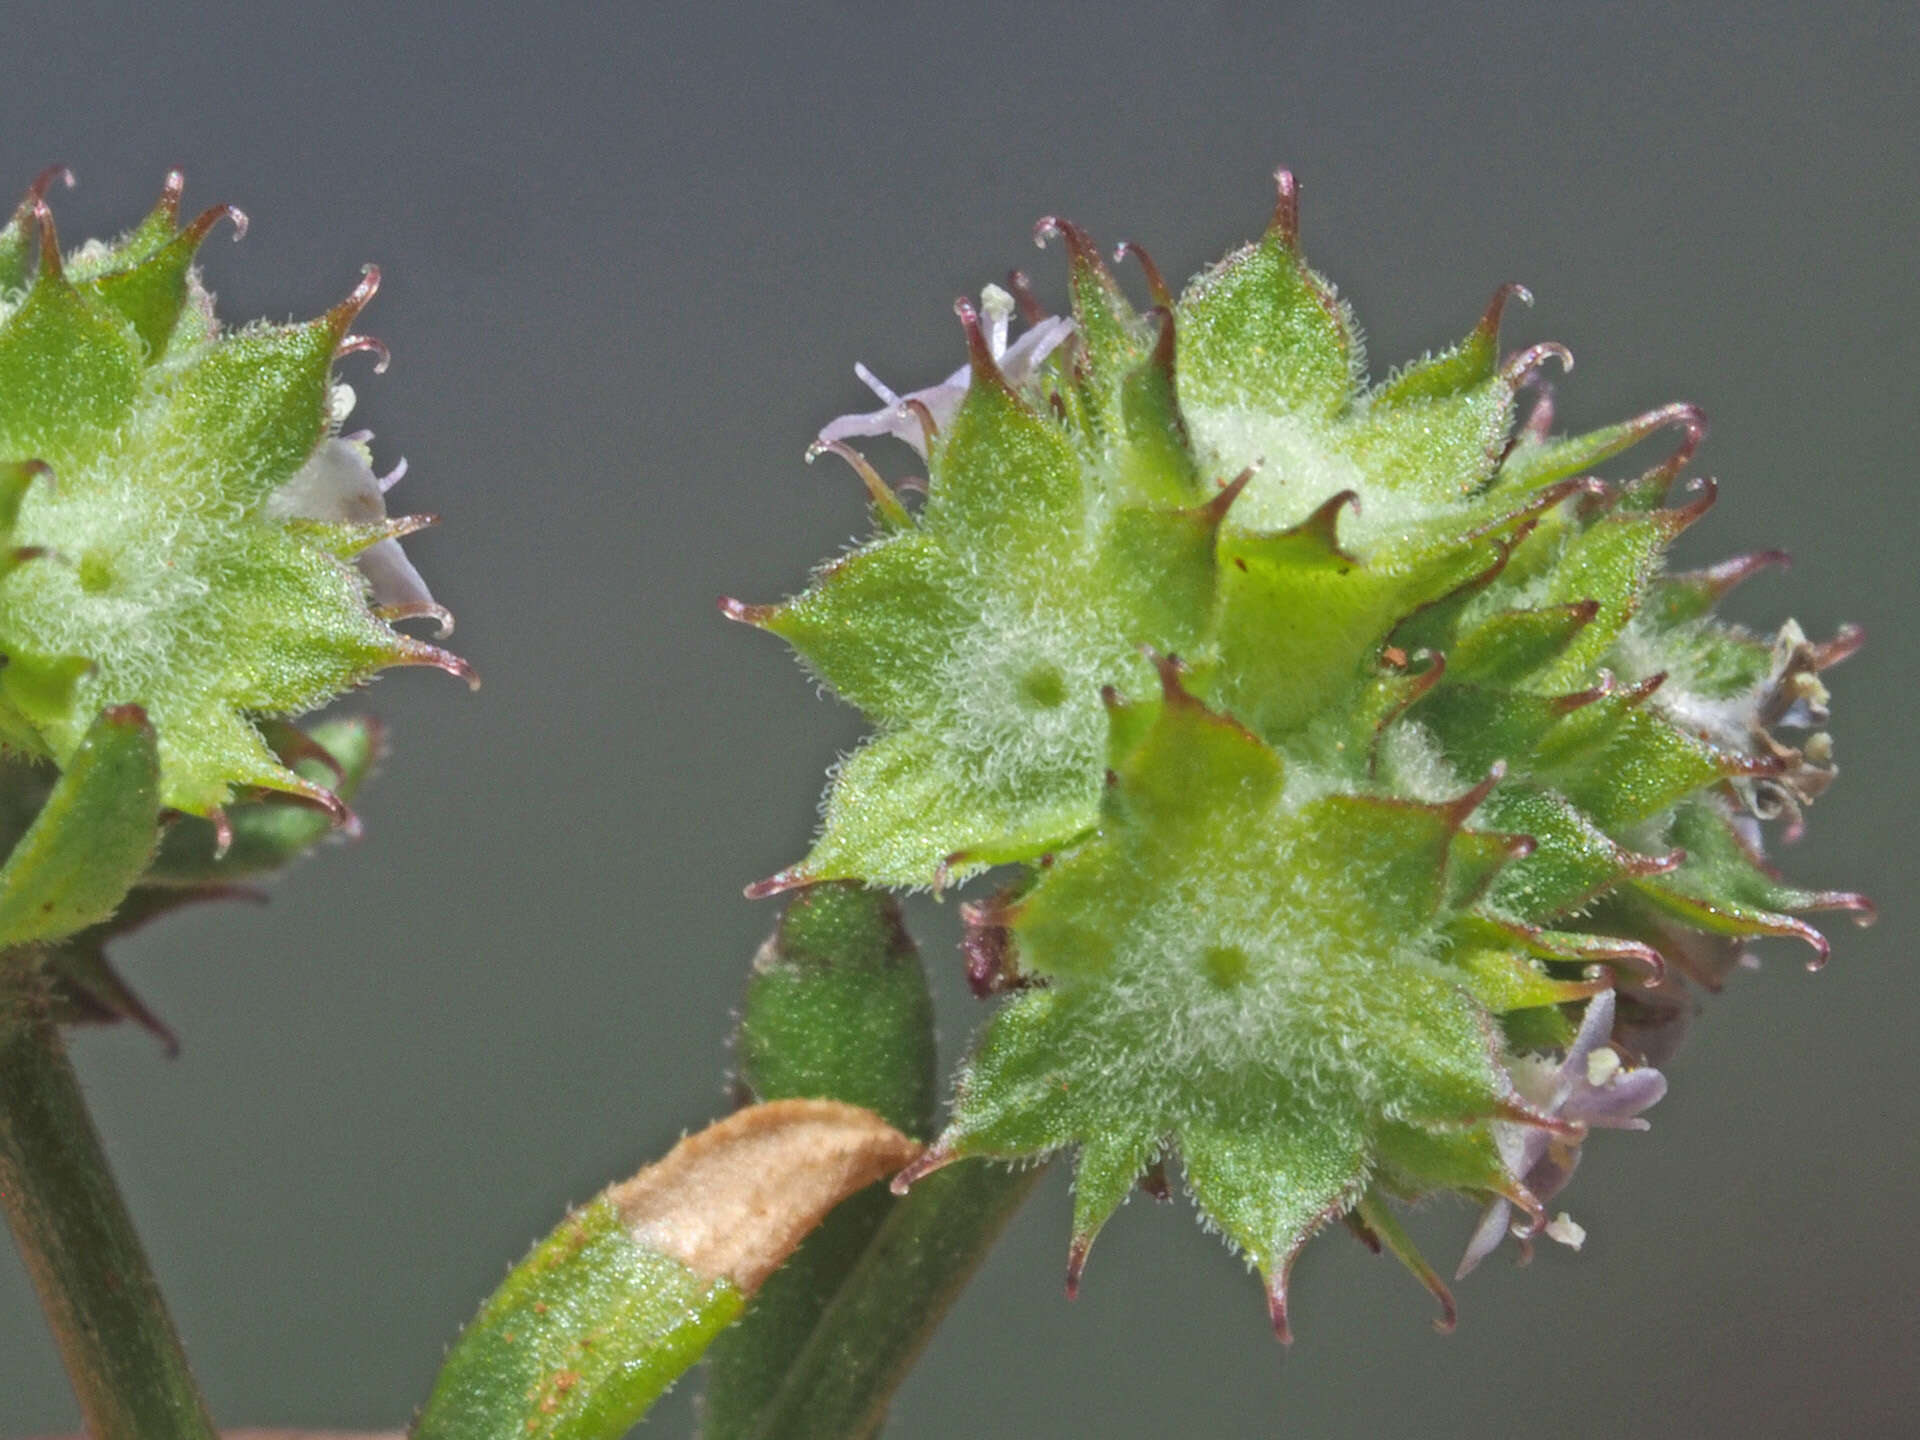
756,1160,1041,1440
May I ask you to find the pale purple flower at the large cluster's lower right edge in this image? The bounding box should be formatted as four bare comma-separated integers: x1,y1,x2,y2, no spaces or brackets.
1453,991,1667,1279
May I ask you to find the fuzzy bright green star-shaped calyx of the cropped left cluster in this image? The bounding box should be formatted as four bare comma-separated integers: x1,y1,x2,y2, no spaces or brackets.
0,173,470,818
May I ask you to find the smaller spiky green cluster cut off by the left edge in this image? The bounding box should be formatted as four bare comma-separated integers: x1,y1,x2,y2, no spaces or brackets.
0,169,472,1046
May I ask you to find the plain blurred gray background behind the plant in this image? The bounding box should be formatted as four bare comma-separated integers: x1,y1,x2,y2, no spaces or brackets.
0,4,1920,1436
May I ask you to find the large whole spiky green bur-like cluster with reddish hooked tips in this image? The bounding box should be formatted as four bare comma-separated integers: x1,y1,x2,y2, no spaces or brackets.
724,173,1866,1334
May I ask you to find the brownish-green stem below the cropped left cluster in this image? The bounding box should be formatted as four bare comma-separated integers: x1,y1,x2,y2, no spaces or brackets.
0,952,215,1440
